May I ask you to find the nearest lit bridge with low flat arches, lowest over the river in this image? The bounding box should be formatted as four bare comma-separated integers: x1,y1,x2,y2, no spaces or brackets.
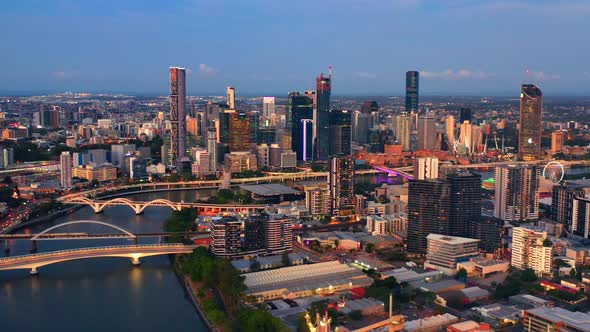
0,243,198,274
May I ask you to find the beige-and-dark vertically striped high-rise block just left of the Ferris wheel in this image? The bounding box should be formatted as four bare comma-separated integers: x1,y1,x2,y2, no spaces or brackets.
494,165,540,221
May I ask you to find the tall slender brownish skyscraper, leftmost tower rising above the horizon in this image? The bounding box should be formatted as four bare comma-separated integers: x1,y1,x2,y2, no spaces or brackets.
169,67,186,172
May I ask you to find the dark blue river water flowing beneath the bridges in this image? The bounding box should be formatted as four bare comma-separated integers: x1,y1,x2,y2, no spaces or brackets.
0,191,211,332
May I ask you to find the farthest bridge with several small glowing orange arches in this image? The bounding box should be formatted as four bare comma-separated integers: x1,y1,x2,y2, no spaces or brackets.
62,196,265,214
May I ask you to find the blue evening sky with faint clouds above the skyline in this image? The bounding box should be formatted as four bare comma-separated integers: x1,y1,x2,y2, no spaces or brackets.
0,0,590,95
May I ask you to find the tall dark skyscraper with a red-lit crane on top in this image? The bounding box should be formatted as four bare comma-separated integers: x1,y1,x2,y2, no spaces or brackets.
313,74,332,160
